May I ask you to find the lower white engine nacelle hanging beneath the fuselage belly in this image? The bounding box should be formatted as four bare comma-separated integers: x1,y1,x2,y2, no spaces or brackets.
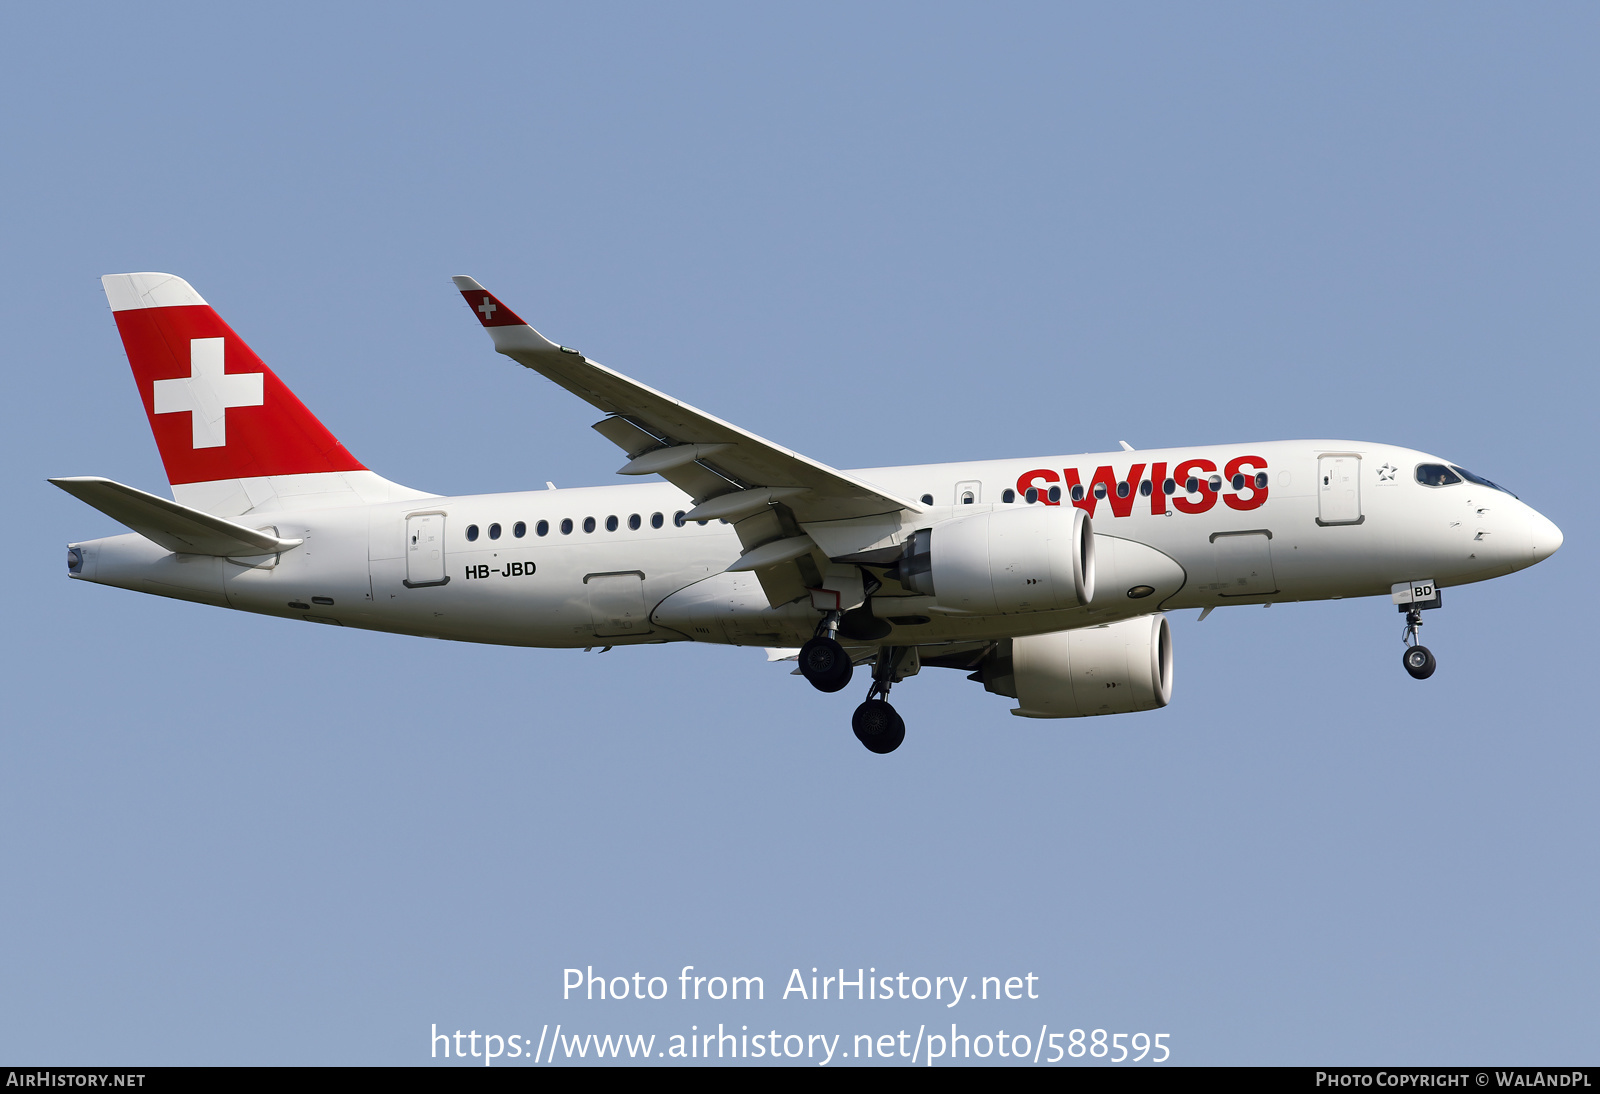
979,614,1173,718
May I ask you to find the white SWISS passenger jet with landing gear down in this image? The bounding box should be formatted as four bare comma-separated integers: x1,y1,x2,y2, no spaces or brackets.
59,274,1562,753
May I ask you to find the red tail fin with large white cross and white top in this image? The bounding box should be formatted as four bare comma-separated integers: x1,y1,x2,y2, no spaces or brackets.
101,274,365,486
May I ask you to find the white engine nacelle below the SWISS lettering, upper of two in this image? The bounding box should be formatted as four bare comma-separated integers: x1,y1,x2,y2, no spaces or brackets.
894,505,1094,616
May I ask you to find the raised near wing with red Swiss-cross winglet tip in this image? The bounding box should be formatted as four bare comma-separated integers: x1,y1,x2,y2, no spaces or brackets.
451,277,922,523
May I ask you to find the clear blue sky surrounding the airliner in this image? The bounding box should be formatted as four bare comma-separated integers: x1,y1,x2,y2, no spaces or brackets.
0,5,1600,1064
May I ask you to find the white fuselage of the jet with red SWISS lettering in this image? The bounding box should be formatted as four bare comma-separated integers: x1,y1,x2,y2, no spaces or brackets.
74,440,1560,646
